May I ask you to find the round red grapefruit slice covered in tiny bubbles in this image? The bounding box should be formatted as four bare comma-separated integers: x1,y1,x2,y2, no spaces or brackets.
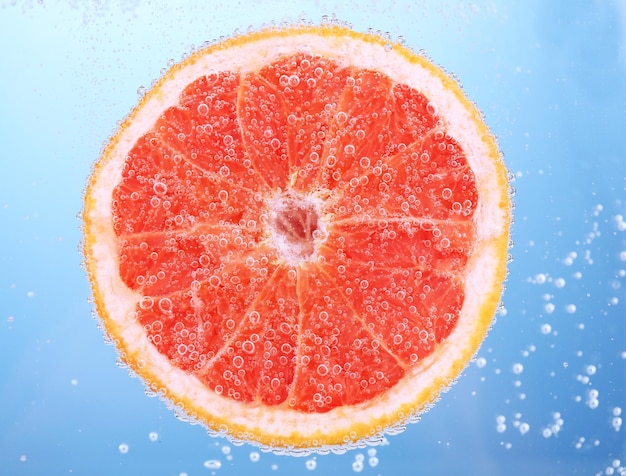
84,25,510,452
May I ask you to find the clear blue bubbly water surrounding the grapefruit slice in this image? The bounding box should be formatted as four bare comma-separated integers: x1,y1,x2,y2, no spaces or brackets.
0,0,626,476
